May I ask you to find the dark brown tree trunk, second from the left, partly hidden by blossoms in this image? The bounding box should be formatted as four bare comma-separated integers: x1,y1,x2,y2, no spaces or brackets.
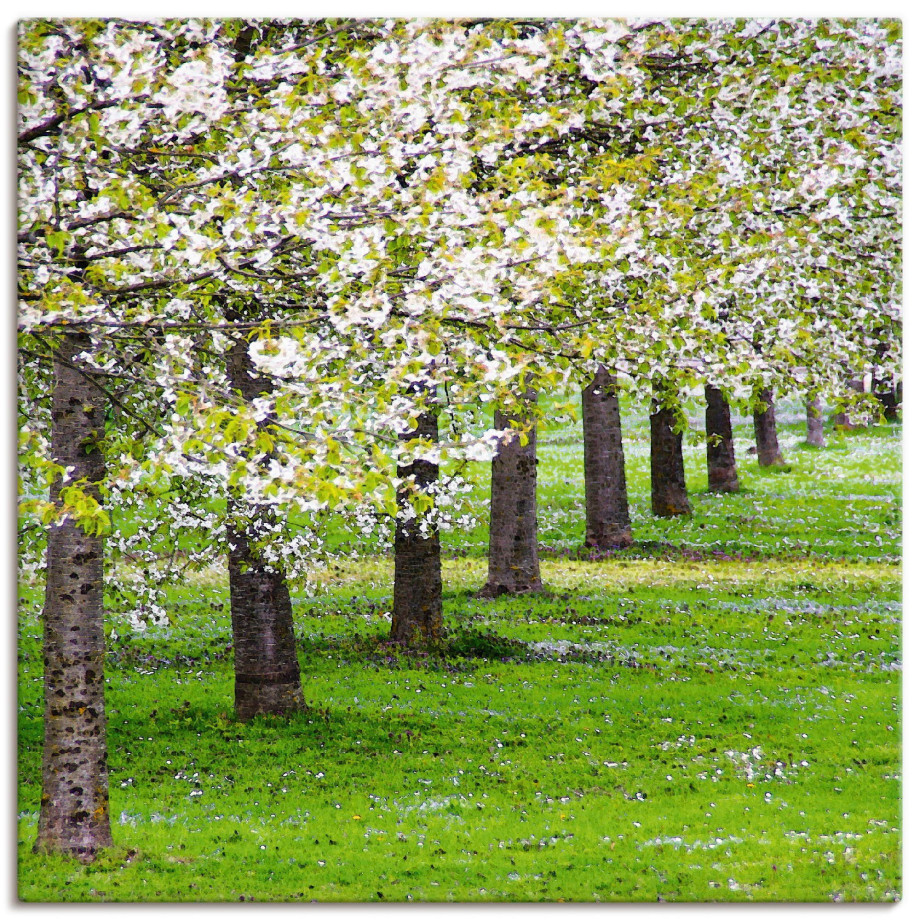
227,328,304,721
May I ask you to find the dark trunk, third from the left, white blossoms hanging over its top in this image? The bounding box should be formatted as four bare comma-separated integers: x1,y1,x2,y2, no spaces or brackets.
390,412,444,644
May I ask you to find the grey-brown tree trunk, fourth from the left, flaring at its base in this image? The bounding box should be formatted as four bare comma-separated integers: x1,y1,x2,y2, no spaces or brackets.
480,395,543,597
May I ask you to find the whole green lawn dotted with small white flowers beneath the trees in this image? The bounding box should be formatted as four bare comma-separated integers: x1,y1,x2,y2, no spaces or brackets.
18,396,902,902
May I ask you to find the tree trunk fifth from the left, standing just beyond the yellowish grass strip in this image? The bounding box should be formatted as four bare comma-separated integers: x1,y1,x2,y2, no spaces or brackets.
581,366,633,549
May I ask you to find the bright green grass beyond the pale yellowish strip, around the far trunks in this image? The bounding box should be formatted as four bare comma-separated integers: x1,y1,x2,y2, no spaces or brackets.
443,402,901,561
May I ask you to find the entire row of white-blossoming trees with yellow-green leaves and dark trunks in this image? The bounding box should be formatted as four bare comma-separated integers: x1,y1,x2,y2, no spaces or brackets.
19,20,900,859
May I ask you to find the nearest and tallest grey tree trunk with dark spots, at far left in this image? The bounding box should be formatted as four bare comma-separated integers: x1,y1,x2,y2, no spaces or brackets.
35,334,112,863
